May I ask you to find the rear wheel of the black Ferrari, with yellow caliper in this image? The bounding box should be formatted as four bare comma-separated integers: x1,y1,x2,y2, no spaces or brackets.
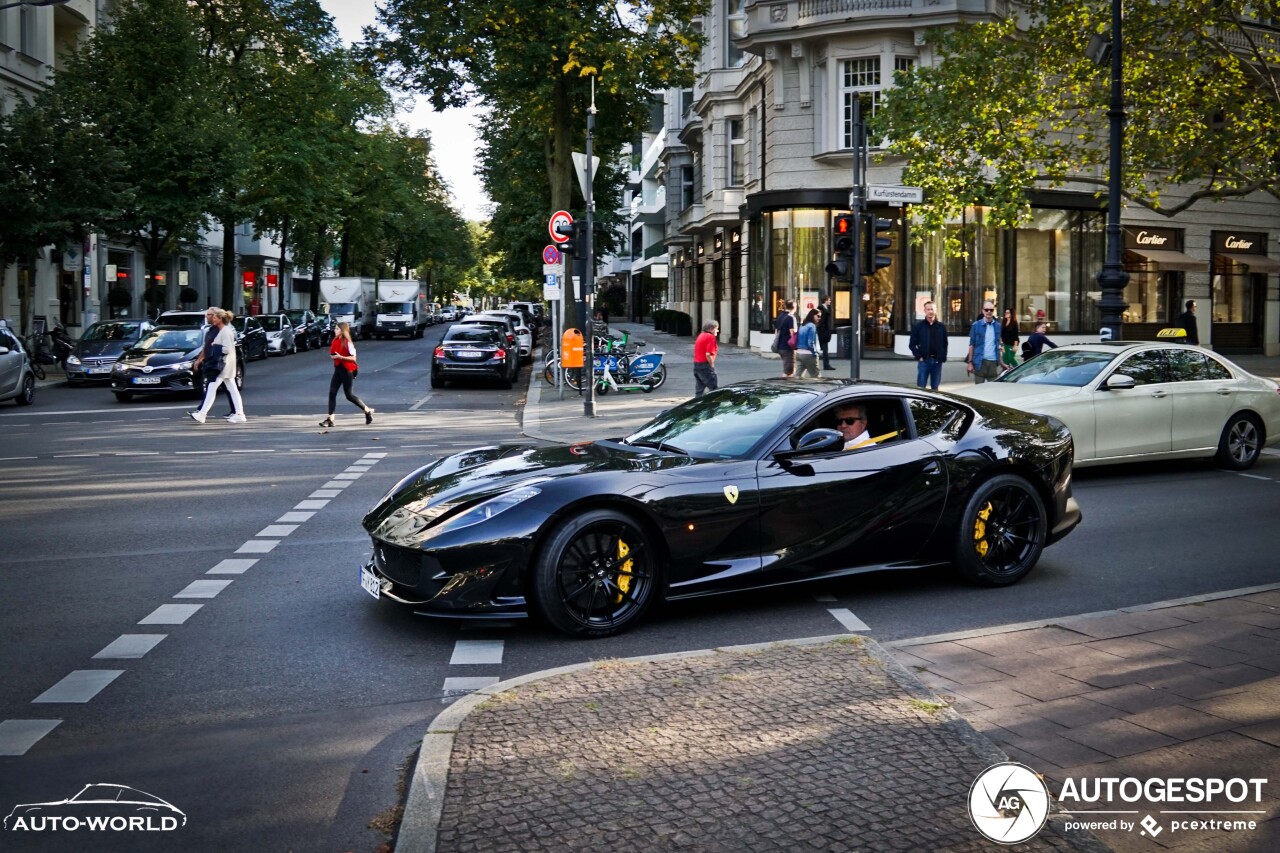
955,474,1047,587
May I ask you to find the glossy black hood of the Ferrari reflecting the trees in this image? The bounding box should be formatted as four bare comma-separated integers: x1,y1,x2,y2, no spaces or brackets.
364,442,694,533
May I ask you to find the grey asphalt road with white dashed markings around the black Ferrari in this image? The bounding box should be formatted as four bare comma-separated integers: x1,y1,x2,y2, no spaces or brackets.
0,328,1280,852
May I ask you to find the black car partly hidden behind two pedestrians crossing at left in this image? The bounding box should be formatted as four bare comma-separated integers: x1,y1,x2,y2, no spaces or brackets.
111,325,244,402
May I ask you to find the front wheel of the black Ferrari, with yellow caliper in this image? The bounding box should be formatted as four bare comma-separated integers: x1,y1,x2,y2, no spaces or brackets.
534,510,658,637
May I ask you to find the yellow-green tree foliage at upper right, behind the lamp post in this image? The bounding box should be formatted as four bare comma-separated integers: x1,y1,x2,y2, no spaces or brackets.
873,0,1280,231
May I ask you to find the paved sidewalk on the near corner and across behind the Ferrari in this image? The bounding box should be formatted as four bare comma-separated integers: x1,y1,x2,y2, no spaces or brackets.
396,322,1280,853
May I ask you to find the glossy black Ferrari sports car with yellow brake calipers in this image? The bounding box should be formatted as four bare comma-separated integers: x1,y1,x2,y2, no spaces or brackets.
361,379,1080,637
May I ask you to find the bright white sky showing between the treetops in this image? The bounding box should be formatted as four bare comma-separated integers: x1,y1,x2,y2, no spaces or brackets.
320,0,493,220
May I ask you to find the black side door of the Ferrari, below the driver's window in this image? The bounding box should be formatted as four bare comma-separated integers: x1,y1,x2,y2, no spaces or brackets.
759,400,947,583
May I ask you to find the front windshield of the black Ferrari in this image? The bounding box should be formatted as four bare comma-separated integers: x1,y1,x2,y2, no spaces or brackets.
623,384,814,459
